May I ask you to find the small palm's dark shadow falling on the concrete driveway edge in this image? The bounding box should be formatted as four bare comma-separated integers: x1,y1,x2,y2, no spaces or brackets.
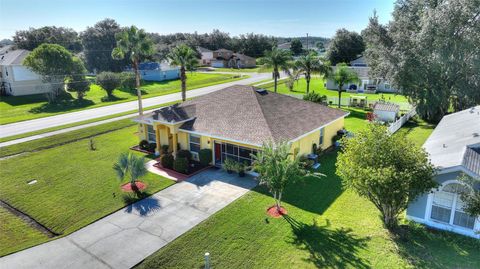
122,192,161,216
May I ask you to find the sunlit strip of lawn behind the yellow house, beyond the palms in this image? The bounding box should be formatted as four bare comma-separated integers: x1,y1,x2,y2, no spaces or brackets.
262,76,408,103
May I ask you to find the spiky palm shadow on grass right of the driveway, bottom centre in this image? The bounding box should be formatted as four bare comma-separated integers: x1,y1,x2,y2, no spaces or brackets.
284,215,370,268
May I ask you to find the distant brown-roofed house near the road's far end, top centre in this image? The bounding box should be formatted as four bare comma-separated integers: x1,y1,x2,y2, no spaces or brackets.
210,49,256,68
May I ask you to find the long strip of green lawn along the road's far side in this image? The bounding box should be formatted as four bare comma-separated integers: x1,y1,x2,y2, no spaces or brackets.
0,73,246,124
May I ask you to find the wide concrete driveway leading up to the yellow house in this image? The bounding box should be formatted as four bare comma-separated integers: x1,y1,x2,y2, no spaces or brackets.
0,169,257,269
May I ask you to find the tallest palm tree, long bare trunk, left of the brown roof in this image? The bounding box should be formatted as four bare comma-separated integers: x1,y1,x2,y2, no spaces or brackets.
112,26,154,115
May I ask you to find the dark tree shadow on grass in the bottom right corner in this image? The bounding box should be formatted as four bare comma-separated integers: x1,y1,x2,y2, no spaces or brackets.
392,222,480,268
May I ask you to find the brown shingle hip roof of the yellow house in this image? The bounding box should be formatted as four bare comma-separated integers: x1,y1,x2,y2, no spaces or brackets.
154,85,348,145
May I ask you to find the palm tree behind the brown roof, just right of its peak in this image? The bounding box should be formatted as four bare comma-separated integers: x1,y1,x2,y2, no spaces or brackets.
263,47,292,92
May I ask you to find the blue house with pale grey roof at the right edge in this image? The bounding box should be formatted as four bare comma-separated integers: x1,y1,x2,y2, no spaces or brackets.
407,106,480,238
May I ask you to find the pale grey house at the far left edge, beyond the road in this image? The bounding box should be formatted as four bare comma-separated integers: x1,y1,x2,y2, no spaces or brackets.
0,46,51,96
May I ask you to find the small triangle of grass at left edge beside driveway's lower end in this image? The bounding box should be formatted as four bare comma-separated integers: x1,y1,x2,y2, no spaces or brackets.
0,207,48,257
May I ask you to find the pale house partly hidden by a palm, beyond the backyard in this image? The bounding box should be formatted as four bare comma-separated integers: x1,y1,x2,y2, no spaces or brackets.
326,56,397,93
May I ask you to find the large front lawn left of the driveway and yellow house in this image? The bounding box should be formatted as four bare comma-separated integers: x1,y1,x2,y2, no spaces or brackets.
0,124,173,255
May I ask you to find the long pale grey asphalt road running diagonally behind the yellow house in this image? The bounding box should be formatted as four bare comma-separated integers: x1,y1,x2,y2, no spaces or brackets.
0,73,272,138
